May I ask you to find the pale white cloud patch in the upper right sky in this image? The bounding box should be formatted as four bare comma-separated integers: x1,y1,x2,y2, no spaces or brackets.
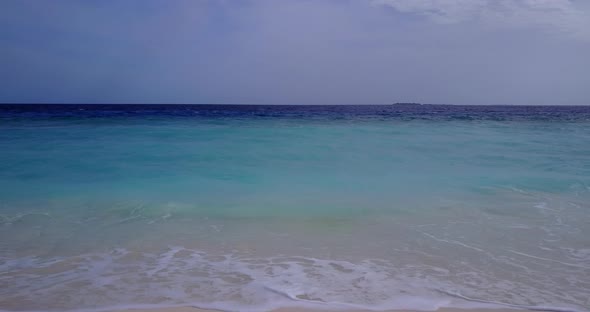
372,0,590,40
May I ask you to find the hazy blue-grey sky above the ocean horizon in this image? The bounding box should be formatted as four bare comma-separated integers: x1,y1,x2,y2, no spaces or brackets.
0,0,590,105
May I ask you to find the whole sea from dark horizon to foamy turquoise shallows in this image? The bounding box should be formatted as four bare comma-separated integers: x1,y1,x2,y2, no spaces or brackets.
0,105,590,311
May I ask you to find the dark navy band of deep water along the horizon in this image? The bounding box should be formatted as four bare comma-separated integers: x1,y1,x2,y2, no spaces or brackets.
0,104,590,121
